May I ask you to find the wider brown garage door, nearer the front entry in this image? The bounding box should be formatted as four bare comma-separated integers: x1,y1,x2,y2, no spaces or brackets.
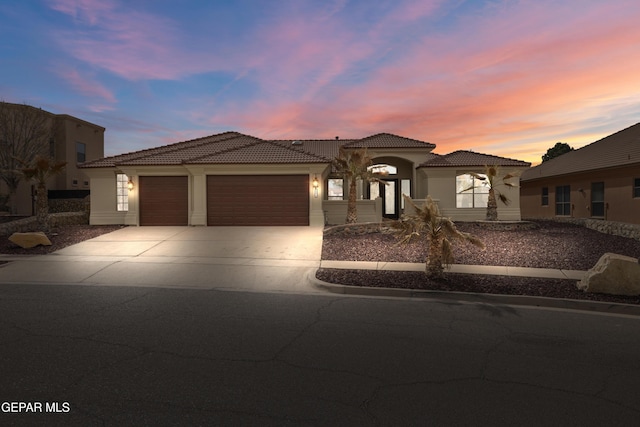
207,175,309,225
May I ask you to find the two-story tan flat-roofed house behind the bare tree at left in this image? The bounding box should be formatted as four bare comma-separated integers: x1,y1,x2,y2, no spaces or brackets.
0,103,105,215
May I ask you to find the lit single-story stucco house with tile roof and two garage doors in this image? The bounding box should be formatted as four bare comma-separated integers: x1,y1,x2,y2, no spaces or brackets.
80,132,529,226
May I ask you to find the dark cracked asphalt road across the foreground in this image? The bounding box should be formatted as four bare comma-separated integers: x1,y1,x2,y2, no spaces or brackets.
0,285,640,426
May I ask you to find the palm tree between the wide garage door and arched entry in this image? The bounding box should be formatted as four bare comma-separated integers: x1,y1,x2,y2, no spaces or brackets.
333,147,384,224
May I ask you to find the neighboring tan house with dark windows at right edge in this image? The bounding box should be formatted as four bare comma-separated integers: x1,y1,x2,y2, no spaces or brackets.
520,123,640,224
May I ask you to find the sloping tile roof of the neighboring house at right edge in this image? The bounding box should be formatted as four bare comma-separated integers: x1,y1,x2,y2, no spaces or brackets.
521,123,640,181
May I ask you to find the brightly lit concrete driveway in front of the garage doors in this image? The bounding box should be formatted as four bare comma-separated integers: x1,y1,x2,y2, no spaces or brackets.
0,227,322,292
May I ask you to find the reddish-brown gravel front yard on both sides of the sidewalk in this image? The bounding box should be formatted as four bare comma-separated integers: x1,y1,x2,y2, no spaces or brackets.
317,221,640,304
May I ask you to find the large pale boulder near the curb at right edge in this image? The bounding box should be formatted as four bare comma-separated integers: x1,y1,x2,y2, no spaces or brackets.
577,253,640,295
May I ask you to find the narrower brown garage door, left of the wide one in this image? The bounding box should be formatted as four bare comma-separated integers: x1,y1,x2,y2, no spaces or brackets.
138,176,189,225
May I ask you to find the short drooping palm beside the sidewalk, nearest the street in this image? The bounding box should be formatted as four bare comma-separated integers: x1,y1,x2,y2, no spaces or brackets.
391,194,484,279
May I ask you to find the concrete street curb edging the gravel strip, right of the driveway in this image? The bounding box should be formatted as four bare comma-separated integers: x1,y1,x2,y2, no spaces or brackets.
308,270,640,316
